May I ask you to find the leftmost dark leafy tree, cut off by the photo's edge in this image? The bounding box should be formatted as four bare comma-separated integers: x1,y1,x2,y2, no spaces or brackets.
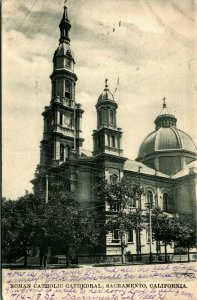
2,192,42,266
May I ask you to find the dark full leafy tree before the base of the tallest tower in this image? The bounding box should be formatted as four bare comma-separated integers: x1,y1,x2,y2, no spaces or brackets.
43,181,100,267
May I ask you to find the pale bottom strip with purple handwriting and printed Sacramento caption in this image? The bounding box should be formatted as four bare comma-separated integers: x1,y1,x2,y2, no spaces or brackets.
2,263,197,300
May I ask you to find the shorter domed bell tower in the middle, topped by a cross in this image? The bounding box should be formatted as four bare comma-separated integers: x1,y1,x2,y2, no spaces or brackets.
93,79,123,157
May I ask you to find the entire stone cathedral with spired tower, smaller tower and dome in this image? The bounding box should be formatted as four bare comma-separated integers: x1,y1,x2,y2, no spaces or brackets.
32,6,197,261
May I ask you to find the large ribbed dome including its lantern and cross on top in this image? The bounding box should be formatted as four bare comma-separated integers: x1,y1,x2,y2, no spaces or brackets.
138,98,197,159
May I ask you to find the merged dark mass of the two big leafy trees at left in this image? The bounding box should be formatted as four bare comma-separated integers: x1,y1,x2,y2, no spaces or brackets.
2,182,100,265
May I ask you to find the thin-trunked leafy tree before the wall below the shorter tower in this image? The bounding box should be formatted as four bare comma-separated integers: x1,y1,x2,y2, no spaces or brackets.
97,176,143,263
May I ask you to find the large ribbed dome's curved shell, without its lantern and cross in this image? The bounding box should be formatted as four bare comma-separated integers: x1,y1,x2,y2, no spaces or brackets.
138,127,197,158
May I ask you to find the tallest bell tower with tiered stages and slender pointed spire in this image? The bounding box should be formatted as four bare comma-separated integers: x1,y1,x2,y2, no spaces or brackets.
40,6,83,167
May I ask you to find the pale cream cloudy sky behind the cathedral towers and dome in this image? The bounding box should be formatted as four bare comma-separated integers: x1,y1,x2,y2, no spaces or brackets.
2,0,197,199
